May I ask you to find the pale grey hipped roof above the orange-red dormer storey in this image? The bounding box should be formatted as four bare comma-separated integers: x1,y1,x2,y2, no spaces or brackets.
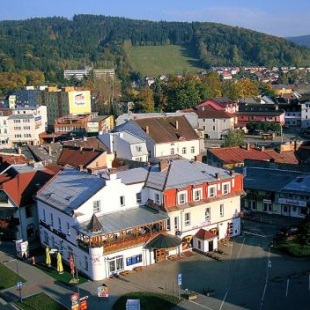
145,159,232,190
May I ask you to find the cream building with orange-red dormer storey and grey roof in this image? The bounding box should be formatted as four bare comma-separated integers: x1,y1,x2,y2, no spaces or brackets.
144,160,243,252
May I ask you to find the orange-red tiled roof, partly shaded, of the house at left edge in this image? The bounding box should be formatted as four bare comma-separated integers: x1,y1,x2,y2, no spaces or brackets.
0,169,54,207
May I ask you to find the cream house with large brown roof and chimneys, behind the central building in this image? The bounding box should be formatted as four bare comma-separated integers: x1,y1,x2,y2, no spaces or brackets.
114,115,200,161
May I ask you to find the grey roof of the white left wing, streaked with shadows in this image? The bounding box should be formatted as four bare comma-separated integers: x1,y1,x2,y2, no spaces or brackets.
37,167,105,214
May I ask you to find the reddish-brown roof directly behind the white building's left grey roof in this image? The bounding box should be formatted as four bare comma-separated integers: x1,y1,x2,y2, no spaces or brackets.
57,147,103,167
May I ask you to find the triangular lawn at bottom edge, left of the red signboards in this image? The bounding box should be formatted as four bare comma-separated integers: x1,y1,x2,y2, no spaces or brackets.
14,293,66,310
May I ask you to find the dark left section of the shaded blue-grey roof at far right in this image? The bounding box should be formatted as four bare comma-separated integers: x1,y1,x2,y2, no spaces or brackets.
243,167,300,192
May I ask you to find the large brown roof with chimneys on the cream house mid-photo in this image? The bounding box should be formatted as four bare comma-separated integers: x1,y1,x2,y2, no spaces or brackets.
134,116,199,143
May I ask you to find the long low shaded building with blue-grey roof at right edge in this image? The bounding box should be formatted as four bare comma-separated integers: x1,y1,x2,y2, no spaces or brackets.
242,167,310,218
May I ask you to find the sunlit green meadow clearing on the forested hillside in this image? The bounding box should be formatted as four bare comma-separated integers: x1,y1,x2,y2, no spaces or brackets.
128,45,201,76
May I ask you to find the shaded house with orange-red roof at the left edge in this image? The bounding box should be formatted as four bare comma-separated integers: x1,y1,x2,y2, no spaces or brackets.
0,162,54,242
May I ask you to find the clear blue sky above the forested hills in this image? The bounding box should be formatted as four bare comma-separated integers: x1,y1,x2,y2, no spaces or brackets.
0,0,310,37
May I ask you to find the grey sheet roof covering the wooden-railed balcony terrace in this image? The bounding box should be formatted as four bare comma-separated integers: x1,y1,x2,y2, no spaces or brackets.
75,206,169,235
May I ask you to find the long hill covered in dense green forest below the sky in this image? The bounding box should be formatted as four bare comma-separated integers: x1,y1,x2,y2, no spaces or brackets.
0,15,310,80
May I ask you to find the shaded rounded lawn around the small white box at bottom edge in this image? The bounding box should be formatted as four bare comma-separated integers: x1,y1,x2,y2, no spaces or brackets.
112,292,179,310
